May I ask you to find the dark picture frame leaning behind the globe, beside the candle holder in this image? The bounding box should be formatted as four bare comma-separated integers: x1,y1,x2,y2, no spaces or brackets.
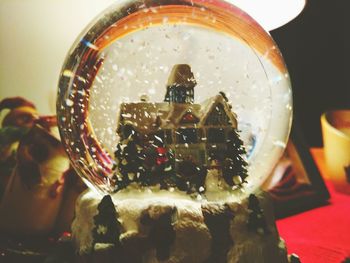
262,120,330,218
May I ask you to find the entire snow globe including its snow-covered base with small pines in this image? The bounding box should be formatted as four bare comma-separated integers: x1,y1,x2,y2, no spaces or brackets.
57,0,292,263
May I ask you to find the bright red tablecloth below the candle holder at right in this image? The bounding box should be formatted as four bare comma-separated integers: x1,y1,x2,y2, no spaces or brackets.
277,149,350,263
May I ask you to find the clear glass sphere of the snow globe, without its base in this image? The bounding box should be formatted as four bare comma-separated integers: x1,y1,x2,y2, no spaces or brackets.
57,0,292,200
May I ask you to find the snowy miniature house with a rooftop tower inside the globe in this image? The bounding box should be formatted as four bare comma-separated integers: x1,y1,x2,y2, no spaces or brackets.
118,64,237,166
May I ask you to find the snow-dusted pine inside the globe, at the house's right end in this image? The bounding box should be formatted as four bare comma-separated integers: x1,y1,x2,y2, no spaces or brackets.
223,130,248,186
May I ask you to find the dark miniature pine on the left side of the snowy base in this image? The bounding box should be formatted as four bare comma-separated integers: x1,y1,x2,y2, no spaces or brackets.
92,195,120,244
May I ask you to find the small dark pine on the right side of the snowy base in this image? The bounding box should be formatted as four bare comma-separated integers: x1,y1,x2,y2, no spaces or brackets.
248,194,268,234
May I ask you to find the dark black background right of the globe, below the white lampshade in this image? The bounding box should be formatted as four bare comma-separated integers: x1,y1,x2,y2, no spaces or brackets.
270,0,350,146
